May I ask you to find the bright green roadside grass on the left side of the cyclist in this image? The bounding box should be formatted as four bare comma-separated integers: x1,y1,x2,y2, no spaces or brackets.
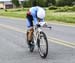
0,9,26,18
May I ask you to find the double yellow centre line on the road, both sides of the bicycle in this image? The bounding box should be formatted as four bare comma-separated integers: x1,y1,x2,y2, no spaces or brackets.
0,24,75,48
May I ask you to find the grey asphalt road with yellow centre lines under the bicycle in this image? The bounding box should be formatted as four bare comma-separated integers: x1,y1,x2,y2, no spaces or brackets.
0,17,75,63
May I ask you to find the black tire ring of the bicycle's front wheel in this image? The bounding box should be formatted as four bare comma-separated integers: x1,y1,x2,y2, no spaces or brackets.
37,32,48,59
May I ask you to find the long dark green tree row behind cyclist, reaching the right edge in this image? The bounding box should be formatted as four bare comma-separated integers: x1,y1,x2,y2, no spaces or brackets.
23,0,75,7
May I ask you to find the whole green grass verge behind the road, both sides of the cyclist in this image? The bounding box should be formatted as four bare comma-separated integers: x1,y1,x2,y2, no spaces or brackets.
0,9,75,23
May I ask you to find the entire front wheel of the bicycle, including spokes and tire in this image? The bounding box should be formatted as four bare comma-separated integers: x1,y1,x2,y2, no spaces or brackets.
37,32,48,58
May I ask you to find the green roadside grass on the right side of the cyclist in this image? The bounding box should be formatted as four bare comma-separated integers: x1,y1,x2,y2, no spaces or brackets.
46,10,75,23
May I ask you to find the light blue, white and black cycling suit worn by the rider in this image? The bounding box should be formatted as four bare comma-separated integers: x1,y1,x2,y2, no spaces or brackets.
26,6,44,27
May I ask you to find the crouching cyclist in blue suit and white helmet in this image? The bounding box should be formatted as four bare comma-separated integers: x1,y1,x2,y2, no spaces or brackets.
26,6,45,45
